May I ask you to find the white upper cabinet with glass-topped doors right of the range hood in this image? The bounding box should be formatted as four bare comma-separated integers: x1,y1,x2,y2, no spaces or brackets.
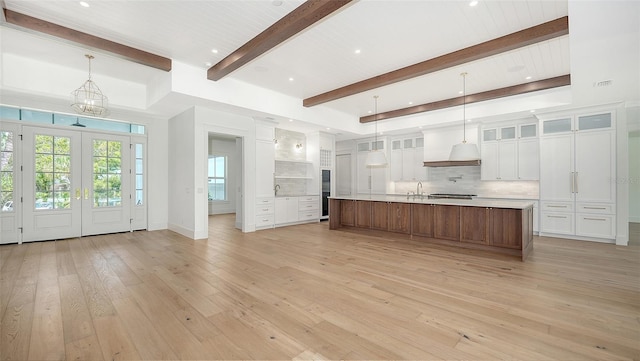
480,124,538,180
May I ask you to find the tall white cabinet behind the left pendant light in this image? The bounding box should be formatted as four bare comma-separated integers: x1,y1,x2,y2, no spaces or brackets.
356,140,388,194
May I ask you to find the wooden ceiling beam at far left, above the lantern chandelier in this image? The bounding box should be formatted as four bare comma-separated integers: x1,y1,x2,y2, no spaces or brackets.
3,9,171,71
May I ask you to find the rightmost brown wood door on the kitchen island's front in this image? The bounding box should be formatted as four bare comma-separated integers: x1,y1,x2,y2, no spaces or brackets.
489,208,523,249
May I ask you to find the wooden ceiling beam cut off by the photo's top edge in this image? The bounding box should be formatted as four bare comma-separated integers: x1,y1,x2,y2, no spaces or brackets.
207,0,353,80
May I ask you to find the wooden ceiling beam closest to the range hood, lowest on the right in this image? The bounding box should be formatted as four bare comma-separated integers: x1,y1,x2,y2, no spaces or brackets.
360,74,571,123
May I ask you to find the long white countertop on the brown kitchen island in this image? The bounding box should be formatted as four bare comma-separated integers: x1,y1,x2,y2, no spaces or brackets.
329,194,533,209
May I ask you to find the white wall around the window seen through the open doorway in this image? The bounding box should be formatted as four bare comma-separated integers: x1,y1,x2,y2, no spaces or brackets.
209,136,242,214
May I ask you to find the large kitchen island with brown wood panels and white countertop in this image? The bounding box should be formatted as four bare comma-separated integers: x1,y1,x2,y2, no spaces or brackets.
329,195,533,261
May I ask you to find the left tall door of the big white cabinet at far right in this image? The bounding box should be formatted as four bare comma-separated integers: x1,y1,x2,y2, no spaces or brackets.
540,134,573,201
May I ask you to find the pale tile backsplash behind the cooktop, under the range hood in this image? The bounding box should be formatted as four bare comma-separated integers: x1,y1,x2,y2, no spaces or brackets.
390,166,539,199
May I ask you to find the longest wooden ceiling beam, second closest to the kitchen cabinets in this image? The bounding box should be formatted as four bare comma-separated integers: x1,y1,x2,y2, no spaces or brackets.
302,16,569,107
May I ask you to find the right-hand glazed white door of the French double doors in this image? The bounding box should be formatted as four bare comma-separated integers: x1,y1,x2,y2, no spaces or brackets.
82,133,132,236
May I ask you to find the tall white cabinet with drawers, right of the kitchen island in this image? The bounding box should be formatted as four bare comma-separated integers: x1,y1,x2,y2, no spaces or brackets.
540,112,616,242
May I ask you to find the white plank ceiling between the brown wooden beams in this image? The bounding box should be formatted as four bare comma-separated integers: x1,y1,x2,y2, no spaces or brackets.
2,0,636,136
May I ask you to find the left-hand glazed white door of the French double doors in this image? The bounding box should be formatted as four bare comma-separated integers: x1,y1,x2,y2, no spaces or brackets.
22,126,82,241
